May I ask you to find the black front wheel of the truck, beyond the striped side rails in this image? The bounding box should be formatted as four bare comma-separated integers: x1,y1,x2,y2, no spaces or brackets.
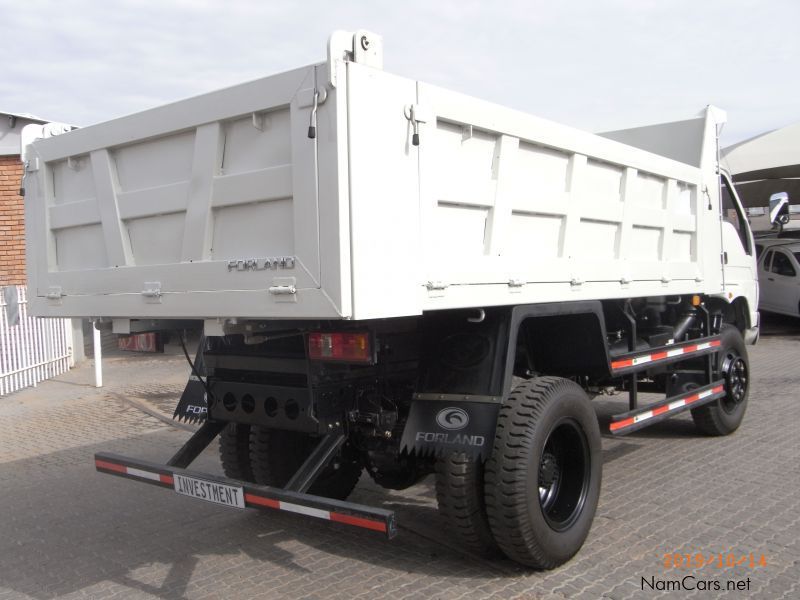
692,325,750,435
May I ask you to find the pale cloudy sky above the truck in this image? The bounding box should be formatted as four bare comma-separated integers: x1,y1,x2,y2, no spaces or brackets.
0,0,800,146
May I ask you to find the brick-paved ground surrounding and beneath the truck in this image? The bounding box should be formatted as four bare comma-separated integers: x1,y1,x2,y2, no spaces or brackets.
0,318,800,600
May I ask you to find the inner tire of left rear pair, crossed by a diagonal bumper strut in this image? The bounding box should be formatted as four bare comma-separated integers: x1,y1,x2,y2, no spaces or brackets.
250,426,361,500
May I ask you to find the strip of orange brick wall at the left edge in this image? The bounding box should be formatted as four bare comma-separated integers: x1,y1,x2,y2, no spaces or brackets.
0,156,25,286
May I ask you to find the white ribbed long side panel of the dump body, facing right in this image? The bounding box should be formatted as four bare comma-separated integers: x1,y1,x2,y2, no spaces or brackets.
419,84,720,308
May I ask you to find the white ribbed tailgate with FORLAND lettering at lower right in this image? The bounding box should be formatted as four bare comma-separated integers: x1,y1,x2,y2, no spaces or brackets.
25,66,348,318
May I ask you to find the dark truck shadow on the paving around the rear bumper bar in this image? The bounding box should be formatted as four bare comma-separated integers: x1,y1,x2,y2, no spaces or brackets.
0,433,536,599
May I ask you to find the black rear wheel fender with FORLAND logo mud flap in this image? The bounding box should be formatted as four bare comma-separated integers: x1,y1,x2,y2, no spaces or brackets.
402,301,610,458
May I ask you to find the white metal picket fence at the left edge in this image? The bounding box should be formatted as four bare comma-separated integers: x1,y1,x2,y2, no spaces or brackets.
0,286,72,396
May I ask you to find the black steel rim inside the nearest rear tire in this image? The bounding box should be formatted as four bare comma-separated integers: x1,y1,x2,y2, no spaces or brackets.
537,418,591,531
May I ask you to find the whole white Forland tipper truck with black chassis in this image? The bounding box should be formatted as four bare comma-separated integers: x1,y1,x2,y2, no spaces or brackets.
24,31,758,568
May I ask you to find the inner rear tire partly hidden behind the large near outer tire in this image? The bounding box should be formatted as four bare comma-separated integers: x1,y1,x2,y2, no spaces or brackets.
436,452,502,557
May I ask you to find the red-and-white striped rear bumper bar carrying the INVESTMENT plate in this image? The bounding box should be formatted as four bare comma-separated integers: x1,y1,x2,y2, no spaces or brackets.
94,452,397,539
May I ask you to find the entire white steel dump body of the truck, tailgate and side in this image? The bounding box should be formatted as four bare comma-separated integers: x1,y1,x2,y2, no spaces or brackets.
24,32,755,319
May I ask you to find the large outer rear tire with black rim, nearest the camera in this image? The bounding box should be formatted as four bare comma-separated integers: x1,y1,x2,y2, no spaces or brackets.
484,377,602,569
